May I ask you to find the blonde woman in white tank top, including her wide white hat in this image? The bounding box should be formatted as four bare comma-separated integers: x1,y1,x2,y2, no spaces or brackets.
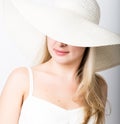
0,0,120,124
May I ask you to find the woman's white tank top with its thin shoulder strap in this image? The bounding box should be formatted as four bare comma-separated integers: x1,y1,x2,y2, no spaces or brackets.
18,67,94,124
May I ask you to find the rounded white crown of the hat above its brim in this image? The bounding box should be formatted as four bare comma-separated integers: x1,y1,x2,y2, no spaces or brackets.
54,0,100,24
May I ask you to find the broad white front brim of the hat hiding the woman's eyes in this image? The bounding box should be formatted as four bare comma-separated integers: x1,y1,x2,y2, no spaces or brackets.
10,0,120,47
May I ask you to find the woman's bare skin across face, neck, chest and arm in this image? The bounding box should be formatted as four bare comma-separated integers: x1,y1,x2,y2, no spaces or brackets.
0,38,106,124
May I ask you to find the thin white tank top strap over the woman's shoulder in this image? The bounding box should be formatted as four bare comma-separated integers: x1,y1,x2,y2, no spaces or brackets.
27,67,33,96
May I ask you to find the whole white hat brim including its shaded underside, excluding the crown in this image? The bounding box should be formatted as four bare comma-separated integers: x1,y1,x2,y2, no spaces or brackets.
4,1,120,71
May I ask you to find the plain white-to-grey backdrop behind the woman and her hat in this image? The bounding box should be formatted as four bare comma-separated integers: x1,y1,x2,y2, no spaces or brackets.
0,0,120,124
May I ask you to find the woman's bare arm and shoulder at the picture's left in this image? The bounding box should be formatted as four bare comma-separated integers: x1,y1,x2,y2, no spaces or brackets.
0,68,28,124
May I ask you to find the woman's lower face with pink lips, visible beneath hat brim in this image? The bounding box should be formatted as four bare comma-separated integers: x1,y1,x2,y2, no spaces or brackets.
47,37,85,64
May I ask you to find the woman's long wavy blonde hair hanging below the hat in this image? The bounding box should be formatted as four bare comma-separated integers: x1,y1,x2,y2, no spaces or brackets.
35,38,105,124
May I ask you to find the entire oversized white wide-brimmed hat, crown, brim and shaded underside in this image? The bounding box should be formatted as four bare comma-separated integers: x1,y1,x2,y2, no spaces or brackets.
3,0,120,71
